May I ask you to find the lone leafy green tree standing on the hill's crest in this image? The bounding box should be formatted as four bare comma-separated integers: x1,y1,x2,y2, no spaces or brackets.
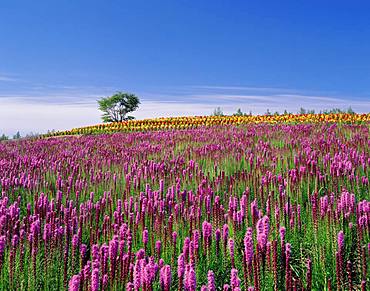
98,92,140,122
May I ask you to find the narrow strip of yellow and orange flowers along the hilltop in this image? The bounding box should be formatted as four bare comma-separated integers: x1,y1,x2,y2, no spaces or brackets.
48,113,370,136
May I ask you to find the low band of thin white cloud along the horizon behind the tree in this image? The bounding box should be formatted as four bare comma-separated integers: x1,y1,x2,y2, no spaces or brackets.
0,94,370,135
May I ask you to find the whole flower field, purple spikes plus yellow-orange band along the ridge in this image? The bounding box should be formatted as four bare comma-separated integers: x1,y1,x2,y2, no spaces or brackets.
0,120,370,291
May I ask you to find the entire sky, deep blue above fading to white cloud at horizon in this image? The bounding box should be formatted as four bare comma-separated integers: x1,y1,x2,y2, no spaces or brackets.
0,0,370,134
